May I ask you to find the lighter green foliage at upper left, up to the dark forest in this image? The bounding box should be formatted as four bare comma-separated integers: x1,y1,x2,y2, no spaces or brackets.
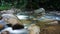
0,0,26,10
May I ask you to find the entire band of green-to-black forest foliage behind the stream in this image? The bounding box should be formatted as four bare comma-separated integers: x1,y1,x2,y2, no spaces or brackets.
0,0,60,10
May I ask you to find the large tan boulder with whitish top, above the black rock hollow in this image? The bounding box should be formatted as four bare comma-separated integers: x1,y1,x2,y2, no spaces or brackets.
2,14,19,25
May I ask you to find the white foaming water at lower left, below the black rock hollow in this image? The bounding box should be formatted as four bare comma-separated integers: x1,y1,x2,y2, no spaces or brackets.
2,27,28,34
